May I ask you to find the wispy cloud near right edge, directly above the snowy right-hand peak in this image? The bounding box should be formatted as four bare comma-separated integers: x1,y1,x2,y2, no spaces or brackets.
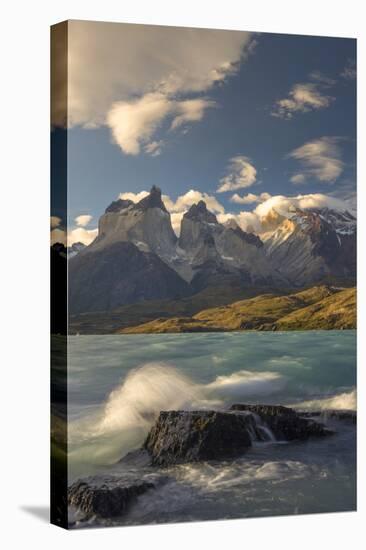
288,136,344,183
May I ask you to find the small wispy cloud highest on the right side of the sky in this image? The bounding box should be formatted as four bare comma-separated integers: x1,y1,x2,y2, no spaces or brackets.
271,82,334,119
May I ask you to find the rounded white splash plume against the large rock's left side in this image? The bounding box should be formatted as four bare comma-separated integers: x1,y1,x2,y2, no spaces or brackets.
69,363,214,471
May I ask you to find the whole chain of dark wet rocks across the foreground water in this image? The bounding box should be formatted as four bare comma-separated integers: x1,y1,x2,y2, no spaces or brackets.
68,403,356,523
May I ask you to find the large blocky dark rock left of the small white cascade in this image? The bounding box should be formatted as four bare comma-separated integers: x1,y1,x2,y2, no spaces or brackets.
144,411,253,466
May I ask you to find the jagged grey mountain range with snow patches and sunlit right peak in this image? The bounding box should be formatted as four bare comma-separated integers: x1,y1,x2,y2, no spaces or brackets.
68,186,356,332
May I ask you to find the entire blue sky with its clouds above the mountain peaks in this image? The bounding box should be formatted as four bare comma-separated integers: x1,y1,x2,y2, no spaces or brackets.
50,22,356,244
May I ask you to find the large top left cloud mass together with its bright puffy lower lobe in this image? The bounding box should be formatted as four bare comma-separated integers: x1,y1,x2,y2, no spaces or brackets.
63,21,253,156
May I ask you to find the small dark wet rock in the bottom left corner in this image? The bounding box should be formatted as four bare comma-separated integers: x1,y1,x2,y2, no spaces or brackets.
68,476,155,518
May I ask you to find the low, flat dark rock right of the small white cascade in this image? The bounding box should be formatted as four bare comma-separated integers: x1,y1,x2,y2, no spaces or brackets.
230,403,333,441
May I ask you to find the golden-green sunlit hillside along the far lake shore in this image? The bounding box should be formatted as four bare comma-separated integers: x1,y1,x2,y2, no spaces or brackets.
117,285,356,334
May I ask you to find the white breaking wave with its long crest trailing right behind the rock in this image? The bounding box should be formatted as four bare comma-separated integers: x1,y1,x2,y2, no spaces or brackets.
69,363,285,474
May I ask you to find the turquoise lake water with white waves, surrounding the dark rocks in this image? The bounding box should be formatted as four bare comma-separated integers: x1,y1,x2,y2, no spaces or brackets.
68,331,356,524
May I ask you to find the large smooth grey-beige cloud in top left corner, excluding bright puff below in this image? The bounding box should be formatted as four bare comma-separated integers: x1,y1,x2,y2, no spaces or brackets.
66,21,252,127
